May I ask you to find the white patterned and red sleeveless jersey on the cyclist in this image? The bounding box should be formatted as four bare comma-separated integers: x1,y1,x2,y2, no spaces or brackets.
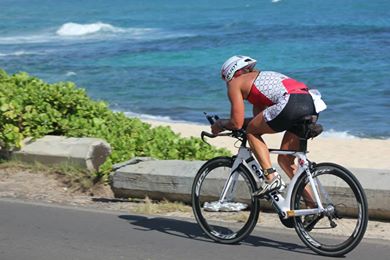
247,71,308,107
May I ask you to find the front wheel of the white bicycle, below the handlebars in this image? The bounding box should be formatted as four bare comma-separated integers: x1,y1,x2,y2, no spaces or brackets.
192,157,260,244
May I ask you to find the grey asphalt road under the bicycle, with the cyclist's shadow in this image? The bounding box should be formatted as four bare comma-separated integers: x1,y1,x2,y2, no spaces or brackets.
0,199,390,260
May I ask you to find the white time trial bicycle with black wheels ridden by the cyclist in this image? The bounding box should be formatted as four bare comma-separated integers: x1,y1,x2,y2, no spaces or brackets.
191,113,368,256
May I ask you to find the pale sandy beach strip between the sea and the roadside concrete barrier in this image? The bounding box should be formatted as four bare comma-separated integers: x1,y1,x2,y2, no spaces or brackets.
143,120,390,170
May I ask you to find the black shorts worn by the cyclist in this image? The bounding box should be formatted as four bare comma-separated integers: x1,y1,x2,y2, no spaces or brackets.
267,94,316,134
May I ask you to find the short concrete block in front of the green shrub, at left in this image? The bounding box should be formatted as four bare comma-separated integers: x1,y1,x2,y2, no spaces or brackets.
11,135,111,172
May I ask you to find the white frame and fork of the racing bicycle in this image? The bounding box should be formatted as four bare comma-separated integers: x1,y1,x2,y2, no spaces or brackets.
219,146,325,219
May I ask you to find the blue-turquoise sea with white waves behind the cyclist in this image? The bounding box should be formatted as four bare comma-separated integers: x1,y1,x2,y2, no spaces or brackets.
0,0,390,139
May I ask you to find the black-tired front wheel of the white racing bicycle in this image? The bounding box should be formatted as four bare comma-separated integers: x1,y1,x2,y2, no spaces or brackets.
191,157,260,244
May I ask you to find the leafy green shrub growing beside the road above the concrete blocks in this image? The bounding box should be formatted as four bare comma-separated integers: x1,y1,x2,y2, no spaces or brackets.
0,70,229,173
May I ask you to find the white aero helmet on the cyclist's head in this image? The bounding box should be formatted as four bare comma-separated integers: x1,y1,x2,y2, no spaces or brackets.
221,55,256,82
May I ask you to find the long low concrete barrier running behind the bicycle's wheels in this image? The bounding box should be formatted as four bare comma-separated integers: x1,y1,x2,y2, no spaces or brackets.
110,158,390,220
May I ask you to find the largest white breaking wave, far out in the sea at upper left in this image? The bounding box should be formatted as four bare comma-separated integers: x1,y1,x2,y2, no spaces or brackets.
56,22,126,36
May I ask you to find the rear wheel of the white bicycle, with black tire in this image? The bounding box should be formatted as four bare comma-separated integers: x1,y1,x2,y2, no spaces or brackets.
291,163,368,257
